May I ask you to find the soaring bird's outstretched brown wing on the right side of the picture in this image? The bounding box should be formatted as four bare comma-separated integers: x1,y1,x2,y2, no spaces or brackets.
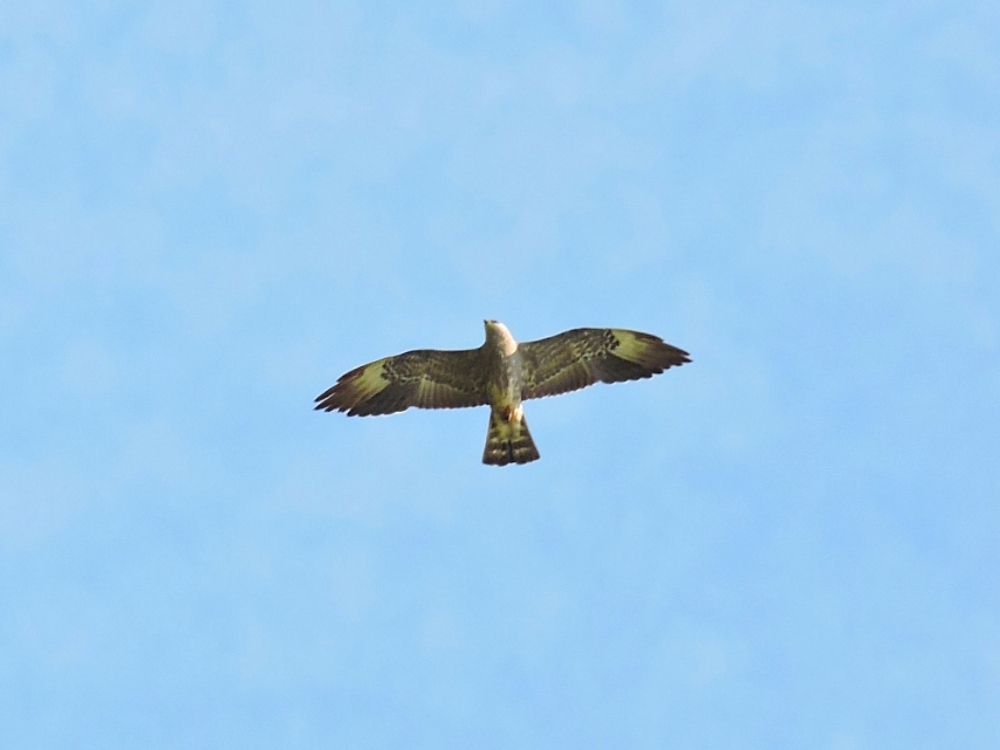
518,328,691,399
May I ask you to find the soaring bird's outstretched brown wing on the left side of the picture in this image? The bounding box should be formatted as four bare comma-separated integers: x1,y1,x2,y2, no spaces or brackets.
316,349,486,417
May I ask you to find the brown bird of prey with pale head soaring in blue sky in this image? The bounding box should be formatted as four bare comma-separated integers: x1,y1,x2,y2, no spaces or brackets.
315,320,691,466
